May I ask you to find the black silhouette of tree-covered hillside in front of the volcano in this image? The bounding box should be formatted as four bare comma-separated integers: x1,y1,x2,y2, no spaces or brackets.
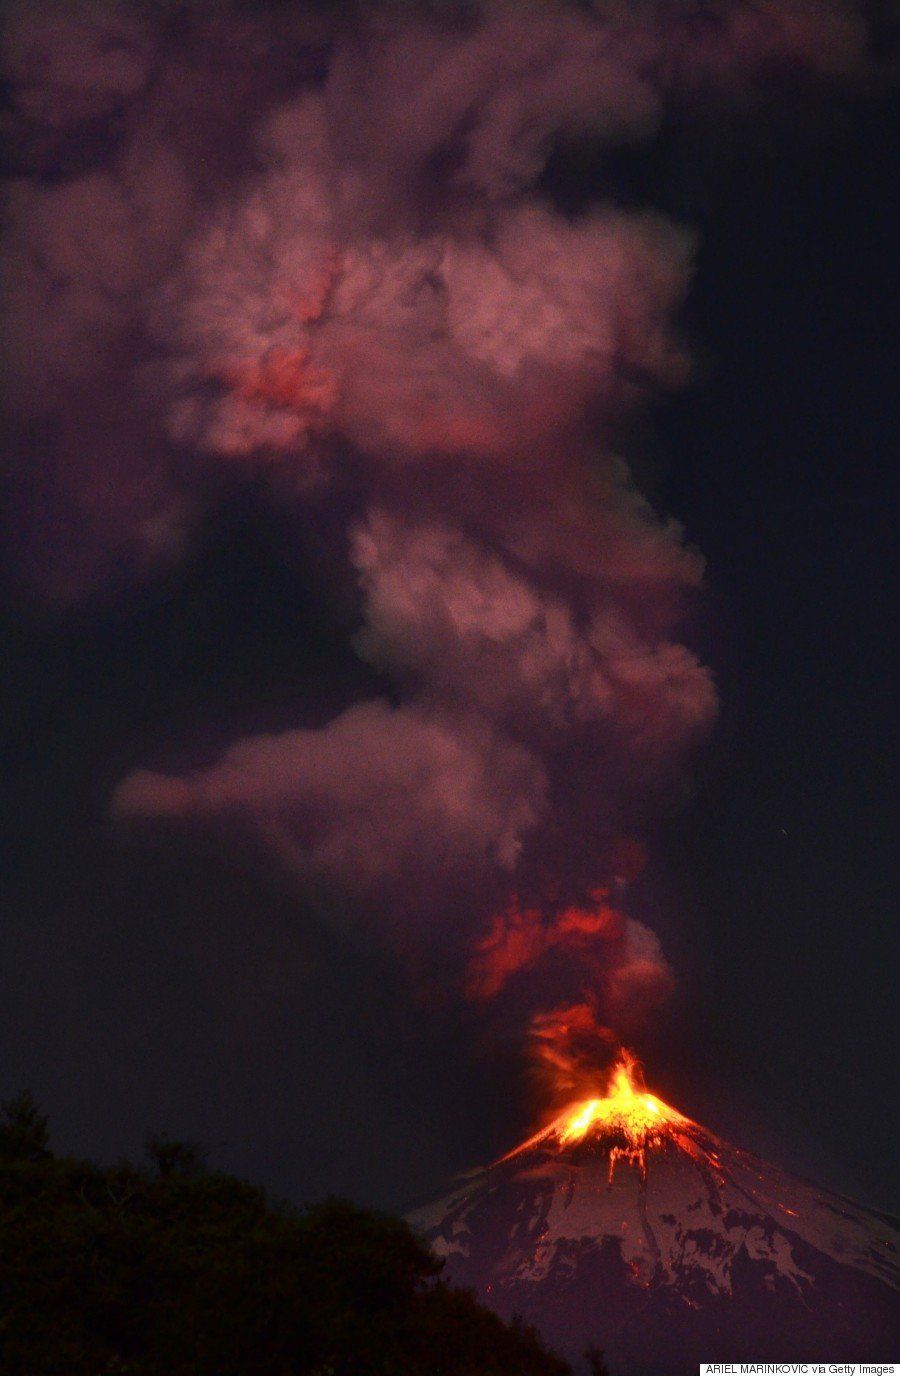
0,1094,577,1376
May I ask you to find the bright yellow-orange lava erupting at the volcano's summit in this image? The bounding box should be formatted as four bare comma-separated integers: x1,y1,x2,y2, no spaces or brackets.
502,1051,691,1181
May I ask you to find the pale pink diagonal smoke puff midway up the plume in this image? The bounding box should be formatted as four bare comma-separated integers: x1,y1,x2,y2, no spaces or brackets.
352,513,716,753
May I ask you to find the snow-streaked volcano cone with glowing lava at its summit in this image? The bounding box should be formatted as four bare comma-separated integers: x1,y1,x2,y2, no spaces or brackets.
409,1060,900,1376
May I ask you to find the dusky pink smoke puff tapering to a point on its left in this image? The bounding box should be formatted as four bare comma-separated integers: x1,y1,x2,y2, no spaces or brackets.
113,702,545,891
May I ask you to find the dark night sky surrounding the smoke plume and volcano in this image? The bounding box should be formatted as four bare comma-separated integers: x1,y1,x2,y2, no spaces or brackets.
0,8,900,1208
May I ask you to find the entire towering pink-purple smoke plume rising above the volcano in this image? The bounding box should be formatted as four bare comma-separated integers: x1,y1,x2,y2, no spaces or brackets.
3,0,864,1047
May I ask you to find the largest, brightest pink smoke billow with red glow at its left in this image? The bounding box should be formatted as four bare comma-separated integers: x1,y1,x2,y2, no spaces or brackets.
158,165,699,462
